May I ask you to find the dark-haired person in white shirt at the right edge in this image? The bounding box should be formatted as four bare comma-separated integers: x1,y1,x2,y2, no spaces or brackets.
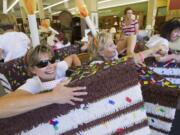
145,19,180,62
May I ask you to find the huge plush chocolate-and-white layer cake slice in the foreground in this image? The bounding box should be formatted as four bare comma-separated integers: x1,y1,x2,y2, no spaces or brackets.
0,59,150,135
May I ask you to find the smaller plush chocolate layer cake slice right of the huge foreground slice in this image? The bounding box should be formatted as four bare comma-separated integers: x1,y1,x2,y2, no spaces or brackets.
139,67,180,135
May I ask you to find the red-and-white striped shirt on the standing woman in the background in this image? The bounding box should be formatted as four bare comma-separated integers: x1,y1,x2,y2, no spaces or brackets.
122,20,138,36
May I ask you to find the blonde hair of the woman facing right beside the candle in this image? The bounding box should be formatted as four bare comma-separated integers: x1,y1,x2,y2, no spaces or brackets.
88,32,112,60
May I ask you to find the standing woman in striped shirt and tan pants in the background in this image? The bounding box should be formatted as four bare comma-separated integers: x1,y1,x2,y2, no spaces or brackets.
117,7,139,55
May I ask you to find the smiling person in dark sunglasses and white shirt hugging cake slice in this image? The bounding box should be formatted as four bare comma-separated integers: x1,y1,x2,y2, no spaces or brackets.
0,45,87,118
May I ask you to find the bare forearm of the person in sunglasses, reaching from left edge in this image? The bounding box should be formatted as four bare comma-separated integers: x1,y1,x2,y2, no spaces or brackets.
0,90,53,118
